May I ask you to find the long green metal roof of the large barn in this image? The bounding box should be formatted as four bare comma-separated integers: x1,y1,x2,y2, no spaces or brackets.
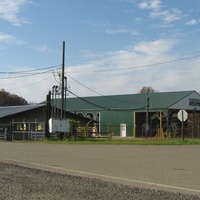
66,91,195,111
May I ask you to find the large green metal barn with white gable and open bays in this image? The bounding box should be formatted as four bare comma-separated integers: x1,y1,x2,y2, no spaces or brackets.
66,91,200,137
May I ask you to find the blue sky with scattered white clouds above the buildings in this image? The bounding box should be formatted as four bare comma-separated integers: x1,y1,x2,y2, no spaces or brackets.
0,0,200,103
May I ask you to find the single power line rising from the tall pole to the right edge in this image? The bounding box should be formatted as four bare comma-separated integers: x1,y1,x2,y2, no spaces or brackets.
68,55,200,74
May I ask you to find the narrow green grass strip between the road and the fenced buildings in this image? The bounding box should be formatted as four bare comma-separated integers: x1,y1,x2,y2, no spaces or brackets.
9,138,200,145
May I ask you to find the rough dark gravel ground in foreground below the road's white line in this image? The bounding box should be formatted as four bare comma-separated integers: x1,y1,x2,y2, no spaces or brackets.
0,162,200,200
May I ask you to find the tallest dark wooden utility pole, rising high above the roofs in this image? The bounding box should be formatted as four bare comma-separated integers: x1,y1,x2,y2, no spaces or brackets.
60,41,65,119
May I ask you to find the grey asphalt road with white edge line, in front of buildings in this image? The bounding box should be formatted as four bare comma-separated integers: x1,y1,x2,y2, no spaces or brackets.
0,142,200,196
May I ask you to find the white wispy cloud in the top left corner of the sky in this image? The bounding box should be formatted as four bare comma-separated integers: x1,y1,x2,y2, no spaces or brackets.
0,0,30,26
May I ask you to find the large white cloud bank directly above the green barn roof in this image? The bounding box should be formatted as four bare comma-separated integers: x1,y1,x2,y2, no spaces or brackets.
67,40,200,96
